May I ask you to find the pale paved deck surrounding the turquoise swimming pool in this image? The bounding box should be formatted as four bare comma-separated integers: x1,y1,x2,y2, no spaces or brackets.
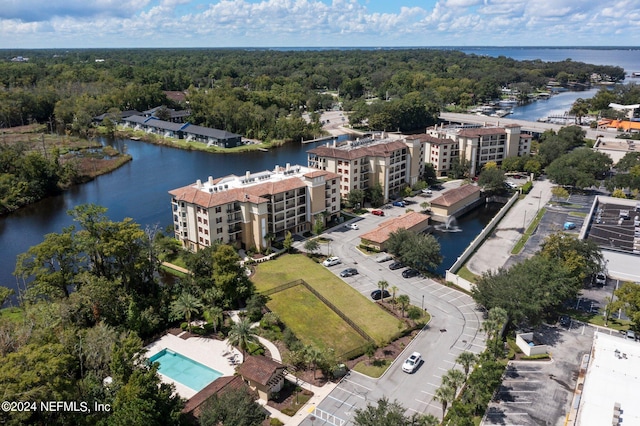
145,333,242,399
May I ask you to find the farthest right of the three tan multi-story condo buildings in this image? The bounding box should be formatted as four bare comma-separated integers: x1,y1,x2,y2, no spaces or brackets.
426,124,531,176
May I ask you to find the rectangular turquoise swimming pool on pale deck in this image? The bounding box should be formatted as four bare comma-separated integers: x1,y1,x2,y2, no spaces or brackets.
149,349,222,392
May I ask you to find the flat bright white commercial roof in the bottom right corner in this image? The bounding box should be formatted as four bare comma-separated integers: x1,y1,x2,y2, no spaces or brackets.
576,332,640,426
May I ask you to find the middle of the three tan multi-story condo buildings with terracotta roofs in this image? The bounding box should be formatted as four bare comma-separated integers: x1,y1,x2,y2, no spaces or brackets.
308,134,424,201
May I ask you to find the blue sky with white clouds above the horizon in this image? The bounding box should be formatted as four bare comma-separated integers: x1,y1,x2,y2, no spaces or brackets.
0,0,640,48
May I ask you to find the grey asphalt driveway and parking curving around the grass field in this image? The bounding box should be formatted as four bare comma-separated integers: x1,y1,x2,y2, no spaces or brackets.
301,211,486,426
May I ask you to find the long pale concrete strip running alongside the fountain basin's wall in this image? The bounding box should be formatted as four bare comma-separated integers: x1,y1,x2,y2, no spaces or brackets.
466,180,554,275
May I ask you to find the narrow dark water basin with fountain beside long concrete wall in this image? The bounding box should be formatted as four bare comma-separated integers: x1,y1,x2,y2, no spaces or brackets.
433,203,502,276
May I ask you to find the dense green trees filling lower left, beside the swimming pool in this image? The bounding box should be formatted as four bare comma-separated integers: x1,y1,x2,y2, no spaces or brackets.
0,205,262,425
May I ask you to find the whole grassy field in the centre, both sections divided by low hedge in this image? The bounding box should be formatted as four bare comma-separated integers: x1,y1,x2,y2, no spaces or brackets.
252,254,404,353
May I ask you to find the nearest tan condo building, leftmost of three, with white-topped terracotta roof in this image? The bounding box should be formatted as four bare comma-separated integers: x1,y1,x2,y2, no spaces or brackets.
169,164,340,251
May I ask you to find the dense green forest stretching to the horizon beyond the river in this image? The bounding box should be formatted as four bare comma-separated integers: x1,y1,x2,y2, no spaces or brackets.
0,49,624,140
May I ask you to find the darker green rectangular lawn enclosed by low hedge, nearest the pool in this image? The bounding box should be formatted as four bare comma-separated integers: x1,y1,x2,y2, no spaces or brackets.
267,286,367,355
